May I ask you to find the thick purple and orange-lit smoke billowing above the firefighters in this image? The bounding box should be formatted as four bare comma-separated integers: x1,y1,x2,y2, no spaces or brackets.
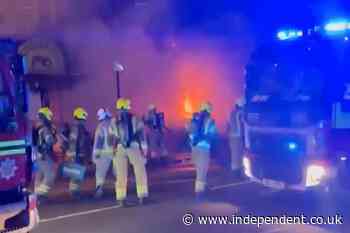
43,0,251,131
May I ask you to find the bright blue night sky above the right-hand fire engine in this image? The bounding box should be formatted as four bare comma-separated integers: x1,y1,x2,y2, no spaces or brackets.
175,0,350,37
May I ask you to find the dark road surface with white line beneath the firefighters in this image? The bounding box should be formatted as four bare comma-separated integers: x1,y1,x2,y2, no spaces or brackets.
33,154,350,233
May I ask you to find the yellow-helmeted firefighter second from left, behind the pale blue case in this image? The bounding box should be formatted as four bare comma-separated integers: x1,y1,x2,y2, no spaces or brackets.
67,107,90,198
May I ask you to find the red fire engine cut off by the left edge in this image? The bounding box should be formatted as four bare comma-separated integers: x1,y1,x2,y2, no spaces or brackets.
0,40,39,233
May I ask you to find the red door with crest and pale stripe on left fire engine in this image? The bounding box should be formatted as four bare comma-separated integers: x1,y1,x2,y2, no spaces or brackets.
0,60,31,190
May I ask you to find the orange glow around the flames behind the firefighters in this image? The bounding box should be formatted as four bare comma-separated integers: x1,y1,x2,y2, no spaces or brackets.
175,50,241,129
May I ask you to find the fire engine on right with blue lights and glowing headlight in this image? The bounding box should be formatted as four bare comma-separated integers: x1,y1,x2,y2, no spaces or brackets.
243,20,350,194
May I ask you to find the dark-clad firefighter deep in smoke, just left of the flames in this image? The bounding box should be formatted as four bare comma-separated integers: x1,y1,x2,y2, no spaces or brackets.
144,104,168,164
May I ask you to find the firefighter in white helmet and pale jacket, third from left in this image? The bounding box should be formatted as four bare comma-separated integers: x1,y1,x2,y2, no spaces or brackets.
92,108,113,198
